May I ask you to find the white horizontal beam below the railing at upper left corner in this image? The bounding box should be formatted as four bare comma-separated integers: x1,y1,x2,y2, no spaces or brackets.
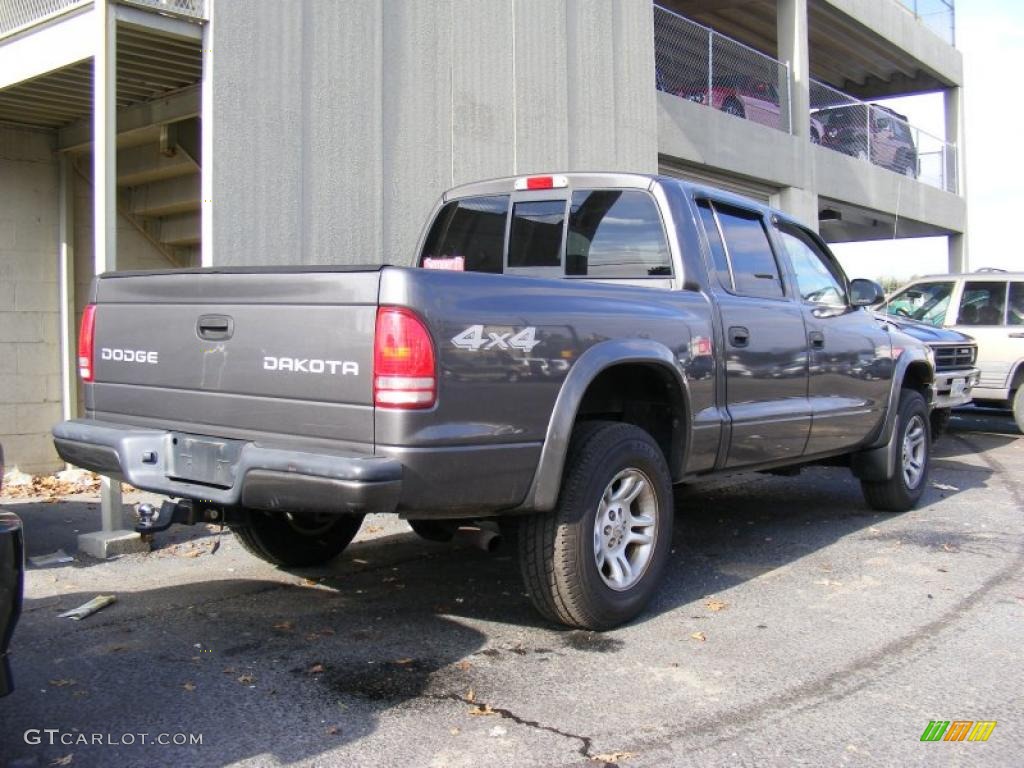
0,7,96,90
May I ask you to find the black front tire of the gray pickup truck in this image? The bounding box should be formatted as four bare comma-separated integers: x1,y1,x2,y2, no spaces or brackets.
860,389,932,512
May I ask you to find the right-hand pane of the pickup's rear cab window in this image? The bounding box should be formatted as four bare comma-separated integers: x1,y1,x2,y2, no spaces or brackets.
569,189,672,278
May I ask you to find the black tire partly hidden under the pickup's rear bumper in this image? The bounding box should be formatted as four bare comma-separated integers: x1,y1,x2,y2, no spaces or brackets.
232,510,362,568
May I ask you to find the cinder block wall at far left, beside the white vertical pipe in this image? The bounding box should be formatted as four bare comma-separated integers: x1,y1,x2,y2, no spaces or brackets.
0,126,60,472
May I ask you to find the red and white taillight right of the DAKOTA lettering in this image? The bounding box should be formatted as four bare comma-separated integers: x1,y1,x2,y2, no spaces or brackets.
374,306,437,409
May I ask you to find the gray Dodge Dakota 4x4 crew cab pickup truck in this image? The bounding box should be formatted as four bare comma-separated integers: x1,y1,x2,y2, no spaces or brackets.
53,173,934,629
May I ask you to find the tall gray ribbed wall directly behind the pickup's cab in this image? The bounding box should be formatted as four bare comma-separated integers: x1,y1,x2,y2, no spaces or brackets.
204,0,657,264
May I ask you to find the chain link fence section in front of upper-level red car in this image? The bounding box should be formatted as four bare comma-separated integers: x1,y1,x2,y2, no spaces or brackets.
654,5,792,133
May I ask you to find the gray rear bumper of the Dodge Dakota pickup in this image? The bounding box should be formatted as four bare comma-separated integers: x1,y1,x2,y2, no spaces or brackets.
53,419,402,514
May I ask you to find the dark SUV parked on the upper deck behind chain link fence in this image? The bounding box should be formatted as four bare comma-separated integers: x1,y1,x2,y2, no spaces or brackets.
812,104,919,178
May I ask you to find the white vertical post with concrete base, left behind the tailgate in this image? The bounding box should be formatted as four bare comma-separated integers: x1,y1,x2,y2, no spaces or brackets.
78,0,147,558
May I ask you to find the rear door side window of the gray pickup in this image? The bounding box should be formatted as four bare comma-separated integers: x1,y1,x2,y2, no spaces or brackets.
709,204,784,298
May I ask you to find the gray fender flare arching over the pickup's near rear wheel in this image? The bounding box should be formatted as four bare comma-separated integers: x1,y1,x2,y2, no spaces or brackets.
515,339,691,512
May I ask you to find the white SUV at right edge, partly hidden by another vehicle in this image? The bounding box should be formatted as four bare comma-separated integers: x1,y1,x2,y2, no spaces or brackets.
885,269,1024,431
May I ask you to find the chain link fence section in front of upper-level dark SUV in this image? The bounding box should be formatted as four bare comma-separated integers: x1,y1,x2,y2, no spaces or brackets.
810,80,957,193
